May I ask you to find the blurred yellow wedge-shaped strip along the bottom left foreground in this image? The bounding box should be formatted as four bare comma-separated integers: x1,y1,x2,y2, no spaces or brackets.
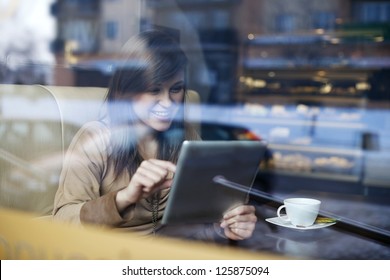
0,209,282,260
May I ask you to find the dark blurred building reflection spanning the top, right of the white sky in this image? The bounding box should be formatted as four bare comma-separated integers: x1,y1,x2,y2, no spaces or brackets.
52,0,390,104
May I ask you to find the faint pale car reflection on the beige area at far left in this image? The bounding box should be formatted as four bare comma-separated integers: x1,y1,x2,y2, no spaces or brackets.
0,119,78,215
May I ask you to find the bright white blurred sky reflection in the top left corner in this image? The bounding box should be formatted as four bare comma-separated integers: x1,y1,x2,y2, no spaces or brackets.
0,0,56,84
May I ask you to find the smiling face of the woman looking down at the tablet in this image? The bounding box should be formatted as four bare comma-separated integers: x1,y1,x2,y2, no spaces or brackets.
132,71,185,131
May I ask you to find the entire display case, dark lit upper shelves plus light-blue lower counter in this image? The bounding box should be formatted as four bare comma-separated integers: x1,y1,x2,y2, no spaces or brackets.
238,33,390,193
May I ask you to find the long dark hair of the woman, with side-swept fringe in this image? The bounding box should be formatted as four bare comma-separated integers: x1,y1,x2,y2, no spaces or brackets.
106,30,187,175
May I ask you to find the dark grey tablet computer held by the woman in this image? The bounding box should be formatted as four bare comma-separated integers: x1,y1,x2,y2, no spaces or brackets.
162,140,266,225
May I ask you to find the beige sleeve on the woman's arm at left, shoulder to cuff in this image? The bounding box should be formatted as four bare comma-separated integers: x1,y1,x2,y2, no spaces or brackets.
53,122,131,226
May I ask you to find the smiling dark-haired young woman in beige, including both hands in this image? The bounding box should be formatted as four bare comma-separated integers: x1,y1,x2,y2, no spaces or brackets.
53,31,256,240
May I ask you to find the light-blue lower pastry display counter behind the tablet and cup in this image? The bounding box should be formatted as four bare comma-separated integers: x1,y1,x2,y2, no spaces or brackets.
232,103,390,194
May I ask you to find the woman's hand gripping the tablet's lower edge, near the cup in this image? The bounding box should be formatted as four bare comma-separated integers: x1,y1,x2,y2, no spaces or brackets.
220,205,257,240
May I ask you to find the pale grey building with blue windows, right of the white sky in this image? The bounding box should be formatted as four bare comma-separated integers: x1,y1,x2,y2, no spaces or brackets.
56,0,141,55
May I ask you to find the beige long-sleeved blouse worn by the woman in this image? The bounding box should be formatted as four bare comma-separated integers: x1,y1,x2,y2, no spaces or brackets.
53,121,199,234
